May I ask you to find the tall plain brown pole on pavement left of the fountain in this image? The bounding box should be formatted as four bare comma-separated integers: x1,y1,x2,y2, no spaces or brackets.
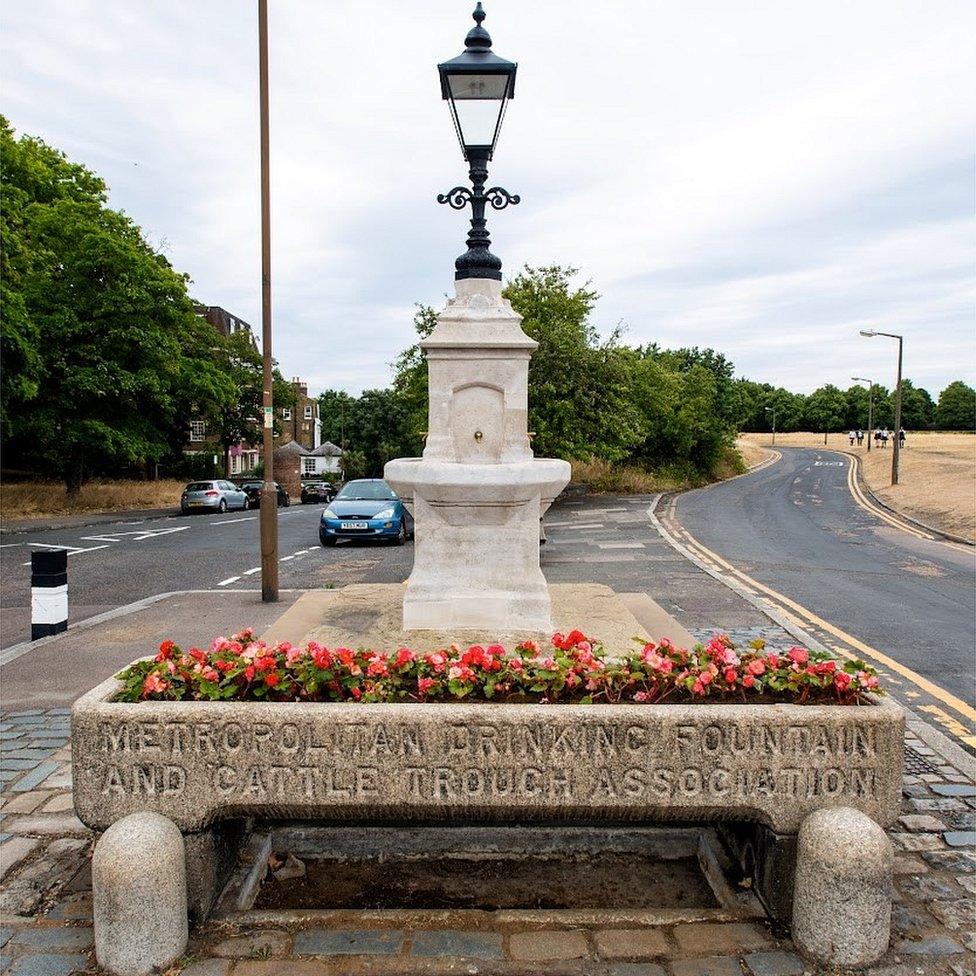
258,0,278,603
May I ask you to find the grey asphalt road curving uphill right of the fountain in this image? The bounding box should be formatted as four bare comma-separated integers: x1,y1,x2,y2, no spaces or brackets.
674,448,976,703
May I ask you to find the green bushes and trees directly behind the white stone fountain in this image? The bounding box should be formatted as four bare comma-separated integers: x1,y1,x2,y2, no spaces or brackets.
319,267,733,480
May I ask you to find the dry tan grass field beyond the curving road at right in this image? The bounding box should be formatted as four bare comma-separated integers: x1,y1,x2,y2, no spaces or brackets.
739,432,976,539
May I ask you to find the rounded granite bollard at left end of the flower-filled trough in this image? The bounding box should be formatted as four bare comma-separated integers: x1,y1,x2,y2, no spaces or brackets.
92,811,189,976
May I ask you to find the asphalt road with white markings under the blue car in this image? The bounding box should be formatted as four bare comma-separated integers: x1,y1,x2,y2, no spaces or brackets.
0,504,413,647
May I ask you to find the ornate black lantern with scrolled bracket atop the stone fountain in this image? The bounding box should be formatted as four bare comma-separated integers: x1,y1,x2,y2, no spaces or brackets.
437,3,520,281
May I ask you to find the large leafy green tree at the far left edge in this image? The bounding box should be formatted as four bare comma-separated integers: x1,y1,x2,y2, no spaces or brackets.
0,122,252,493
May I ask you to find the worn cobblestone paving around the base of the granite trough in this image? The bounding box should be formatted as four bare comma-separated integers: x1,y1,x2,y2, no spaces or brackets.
0,704,976,976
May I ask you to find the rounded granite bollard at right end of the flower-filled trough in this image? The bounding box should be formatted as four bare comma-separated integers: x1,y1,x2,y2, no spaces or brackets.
793,807,893,966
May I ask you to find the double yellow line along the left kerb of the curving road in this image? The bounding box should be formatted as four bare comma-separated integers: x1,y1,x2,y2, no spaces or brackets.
659,498,976,747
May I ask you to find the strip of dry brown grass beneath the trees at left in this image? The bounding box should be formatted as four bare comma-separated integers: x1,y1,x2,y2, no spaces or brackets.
0,479,186,519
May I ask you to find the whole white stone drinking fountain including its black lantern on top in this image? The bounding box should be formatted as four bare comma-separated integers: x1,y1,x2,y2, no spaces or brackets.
384,3,570,633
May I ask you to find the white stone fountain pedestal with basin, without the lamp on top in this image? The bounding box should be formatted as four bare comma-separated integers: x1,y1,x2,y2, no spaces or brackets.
384,279,570,631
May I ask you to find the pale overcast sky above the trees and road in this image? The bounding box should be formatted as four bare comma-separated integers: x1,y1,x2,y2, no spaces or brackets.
0,0,976,395
